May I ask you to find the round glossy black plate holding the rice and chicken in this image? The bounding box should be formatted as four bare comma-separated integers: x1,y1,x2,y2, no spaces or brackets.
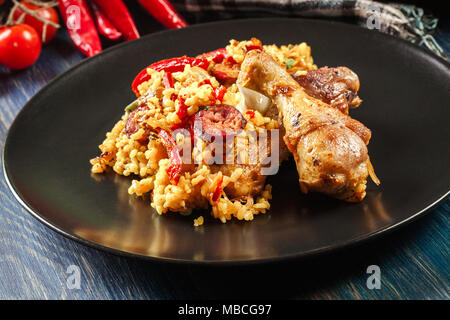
4,19,450,263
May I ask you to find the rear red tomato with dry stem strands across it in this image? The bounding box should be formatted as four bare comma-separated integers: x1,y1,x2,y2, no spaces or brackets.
13,1,59,43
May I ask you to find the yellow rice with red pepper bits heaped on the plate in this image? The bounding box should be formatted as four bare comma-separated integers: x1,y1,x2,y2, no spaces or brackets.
90,38,317,222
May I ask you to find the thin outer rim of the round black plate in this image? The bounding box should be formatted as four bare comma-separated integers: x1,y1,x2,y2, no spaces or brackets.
2,17,450,266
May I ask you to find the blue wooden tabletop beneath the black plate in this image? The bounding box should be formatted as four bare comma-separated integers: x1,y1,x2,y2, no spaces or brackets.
0,13,450,299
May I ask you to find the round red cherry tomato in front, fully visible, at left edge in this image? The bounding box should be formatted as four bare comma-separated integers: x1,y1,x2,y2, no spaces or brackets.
0,24,42,70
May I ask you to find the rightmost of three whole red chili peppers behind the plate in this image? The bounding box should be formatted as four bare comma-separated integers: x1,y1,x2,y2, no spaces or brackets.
138,0,188,29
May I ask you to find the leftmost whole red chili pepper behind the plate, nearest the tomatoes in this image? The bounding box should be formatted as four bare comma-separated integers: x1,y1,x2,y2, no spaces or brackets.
58,0,102,57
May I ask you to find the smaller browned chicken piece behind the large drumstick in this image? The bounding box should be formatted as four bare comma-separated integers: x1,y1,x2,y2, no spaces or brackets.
292,67,362,114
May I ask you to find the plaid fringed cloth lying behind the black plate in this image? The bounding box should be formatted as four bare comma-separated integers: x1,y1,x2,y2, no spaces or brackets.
172,0,446,58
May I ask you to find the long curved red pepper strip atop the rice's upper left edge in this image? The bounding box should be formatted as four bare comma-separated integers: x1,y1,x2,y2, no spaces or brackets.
131,57,210,96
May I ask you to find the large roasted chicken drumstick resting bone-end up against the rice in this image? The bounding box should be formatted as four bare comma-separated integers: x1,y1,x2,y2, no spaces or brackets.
237,50,371,202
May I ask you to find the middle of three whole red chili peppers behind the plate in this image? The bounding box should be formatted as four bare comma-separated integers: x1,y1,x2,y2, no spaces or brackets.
94,0,139,40
